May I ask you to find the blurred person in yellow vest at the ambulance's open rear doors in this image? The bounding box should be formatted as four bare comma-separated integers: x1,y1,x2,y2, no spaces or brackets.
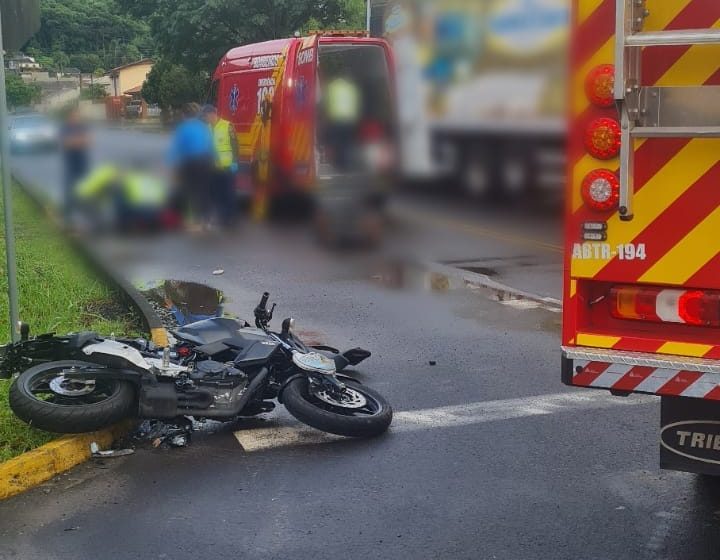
325,73,362,171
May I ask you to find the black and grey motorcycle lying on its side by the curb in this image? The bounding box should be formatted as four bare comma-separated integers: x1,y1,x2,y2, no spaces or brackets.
0,293,392,437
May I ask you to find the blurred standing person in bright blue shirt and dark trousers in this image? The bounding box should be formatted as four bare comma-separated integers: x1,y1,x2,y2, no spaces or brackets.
168,103,215,228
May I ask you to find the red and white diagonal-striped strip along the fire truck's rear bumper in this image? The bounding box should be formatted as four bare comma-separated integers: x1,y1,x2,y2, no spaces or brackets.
572,360,720,401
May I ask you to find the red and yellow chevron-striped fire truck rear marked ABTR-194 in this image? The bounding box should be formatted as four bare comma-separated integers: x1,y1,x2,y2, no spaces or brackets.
562,0,720,475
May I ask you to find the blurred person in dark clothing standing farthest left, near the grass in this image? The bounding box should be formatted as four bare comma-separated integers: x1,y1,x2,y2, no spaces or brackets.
60,110,90,224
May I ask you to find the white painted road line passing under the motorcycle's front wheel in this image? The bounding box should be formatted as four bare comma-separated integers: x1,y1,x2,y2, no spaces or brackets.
235,391,657,452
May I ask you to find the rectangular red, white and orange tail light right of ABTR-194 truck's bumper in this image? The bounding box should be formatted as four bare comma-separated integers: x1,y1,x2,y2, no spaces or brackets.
610,286,720,327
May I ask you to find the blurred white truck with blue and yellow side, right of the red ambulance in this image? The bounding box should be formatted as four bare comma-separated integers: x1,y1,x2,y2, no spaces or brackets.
370,0,569,200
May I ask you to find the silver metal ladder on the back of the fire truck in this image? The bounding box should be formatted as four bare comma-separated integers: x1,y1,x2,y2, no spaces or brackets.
615,0,720,221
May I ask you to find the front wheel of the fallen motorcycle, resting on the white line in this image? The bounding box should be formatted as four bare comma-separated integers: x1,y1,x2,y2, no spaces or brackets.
282,378,393,438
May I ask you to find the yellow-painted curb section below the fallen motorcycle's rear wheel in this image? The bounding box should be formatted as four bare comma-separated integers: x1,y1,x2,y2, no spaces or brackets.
0,421,132,500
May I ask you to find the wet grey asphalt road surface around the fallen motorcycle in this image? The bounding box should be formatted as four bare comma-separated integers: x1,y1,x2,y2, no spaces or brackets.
0,128,720,560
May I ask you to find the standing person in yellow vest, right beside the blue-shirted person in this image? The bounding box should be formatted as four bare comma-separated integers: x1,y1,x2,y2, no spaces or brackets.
203,105,240,227
